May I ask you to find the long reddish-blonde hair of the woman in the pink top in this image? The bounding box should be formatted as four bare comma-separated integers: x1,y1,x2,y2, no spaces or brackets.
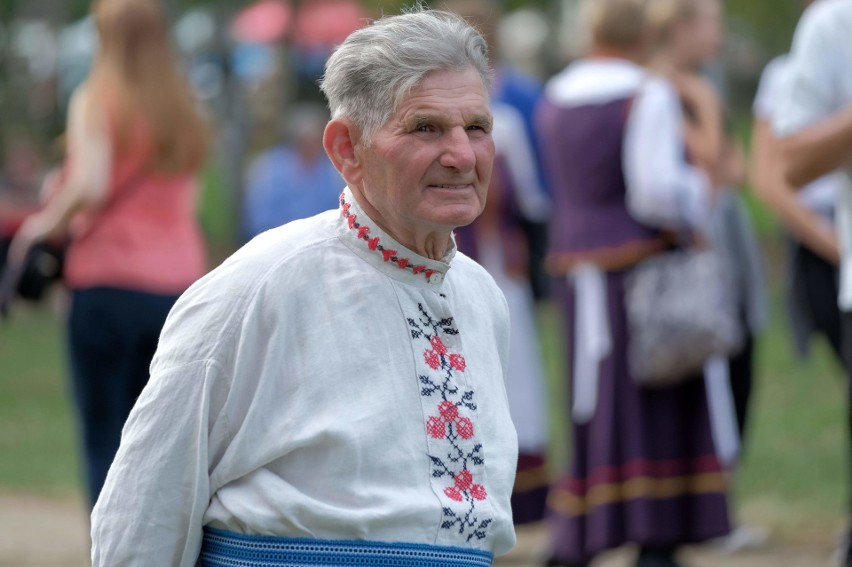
89,0,208,173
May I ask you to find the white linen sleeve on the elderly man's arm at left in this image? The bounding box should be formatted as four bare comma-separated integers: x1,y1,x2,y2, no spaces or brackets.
91,259,251,567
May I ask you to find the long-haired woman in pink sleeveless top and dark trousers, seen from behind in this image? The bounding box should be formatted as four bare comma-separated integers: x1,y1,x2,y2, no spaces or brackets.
10,0,206,508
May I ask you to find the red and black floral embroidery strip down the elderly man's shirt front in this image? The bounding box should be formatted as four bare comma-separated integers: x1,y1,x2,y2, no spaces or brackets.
408,304,493,541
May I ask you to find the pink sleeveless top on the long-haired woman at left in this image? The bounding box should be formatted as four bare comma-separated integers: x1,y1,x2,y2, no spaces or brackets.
65,105,206,295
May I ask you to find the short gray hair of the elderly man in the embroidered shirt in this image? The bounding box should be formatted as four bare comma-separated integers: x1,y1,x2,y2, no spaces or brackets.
320,3,492,144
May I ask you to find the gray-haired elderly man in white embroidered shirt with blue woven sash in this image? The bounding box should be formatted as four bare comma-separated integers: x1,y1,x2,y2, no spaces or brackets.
92,11,517,567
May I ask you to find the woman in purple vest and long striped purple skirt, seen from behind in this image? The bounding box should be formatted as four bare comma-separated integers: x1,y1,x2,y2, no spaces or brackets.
536,0,730,567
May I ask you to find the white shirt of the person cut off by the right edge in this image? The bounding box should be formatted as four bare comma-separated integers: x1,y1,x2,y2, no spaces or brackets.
772,0,852,311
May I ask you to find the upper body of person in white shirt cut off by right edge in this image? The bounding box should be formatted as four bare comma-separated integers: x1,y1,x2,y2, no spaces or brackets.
773,0,852,566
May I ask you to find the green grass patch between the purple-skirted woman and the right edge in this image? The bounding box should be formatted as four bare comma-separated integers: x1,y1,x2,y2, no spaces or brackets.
736,302,850,541
